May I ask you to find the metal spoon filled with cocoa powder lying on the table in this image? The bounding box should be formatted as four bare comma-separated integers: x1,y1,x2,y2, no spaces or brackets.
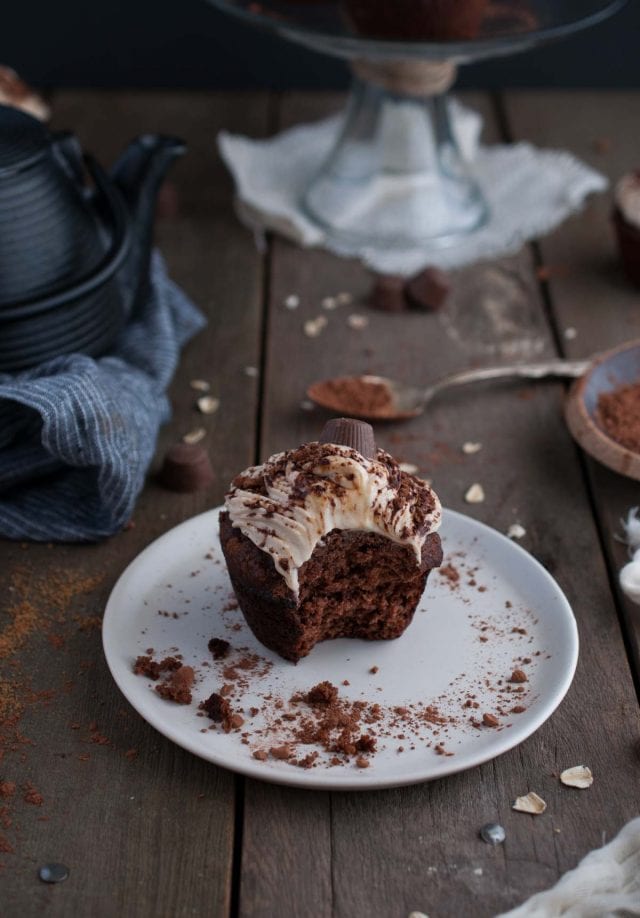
307,360,591,421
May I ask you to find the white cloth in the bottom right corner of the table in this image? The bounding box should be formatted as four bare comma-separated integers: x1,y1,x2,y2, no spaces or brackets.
497,817,640,918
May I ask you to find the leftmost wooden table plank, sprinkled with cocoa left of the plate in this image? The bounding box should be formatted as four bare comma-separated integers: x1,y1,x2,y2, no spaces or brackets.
0,92,268,918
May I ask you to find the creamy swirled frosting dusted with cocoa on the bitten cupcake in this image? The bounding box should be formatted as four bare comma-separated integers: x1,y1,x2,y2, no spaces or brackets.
225,443,441,596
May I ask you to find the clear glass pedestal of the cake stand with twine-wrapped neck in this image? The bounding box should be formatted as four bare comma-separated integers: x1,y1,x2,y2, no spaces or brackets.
302,58,488,248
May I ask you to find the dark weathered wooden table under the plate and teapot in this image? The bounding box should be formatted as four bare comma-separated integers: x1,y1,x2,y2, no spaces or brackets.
0,92,640,918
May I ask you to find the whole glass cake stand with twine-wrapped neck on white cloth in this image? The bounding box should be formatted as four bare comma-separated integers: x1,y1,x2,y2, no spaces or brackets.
209,0,626,248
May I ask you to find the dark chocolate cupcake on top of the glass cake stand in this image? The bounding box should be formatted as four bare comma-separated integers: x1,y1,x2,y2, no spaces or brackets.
344,0,488,41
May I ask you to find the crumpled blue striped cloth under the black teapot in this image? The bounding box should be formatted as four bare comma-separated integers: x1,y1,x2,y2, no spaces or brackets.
0,252,205,542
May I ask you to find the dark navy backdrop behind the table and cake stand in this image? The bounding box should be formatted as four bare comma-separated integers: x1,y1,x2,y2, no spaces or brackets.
0,0,640,89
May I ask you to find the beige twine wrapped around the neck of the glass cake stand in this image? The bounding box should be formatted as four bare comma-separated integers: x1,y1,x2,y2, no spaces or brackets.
351,58,457,96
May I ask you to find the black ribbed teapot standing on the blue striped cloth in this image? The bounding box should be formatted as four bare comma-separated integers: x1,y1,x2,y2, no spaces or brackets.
0,105,185,371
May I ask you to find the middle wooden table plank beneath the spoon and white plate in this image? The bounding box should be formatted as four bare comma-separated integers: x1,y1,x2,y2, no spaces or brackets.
241,90,640,918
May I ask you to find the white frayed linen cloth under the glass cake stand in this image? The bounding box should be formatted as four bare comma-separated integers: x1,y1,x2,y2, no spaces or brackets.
218,100,607,275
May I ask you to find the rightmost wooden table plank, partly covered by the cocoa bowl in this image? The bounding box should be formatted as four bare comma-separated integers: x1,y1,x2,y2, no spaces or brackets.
505,92,640,680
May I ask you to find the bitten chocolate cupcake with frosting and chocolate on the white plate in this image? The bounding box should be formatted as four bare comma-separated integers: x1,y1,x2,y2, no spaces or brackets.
220,418,442,663
